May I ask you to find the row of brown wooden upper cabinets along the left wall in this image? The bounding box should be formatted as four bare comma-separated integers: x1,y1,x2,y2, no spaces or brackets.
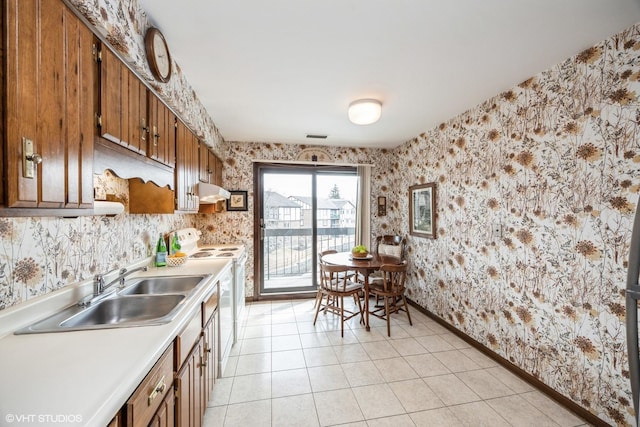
0,0,222,216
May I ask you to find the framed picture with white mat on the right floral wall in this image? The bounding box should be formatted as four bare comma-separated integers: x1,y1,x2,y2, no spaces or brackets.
409,182,436,239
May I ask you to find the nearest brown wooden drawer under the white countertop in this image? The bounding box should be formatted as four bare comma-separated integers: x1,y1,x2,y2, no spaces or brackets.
125,346,173,427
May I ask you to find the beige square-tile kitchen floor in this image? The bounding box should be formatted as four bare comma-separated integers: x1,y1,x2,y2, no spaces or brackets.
204,300,586,427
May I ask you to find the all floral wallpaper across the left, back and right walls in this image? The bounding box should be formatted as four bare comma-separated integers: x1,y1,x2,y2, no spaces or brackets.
0,0,640,425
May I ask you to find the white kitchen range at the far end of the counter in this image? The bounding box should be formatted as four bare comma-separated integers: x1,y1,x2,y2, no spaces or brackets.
177,228,247,374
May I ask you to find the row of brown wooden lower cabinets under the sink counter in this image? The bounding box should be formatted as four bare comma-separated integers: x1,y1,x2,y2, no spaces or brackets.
109,284,219,427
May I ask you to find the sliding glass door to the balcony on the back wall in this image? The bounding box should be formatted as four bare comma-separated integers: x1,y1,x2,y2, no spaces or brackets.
255,164,358,296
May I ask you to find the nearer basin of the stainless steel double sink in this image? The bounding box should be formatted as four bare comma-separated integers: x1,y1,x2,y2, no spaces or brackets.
60,294,185,329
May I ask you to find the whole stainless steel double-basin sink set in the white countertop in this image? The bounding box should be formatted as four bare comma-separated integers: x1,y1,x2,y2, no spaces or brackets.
15,274,210,335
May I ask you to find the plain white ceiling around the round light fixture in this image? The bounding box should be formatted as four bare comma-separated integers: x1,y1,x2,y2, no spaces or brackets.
139,0,640,147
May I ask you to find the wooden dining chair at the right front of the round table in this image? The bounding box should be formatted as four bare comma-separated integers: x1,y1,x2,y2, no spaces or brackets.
369,261,413,336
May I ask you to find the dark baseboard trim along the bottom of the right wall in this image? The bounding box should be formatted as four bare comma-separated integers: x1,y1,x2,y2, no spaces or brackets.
407,298,610,427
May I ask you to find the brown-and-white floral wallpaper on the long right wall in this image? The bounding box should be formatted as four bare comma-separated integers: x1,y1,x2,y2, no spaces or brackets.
393,25,640,425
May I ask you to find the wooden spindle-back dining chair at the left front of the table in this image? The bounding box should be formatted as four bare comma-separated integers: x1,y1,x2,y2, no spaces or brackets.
313,262,364,337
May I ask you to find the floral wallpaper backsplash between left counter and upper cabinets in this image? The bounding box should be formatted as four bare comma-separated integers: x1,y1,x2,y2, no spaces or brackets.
0,172,195,310
